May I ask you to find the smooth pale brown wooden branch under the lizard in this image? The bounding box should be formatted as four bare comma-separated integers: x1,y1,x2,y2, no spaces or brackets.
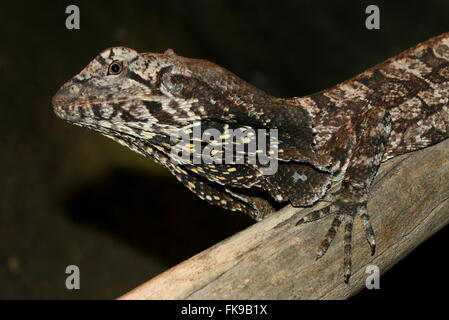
120,140,449,299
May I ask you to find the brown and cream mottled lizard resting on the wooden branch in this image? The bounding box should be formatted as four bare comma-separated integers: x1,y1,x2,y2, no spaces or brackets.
52,33,449,283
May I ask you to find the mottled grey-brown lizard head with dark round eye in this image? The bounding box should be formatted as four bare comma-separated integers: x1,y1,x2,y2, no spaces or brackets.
52,47,268,137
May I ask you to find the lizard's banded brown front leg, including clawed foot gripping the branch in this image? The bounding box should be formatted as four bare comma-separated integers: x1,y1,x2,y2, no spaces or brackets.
297,107,391,283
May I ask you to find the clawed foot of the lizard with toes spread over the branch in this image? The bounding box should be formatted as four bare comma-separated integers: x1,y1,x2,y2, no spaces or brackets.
296,191,376,283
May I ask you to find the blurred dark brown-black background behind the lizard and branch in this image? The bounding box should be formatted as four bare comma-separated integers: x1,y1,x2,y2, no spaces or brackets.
0,0,449,299
